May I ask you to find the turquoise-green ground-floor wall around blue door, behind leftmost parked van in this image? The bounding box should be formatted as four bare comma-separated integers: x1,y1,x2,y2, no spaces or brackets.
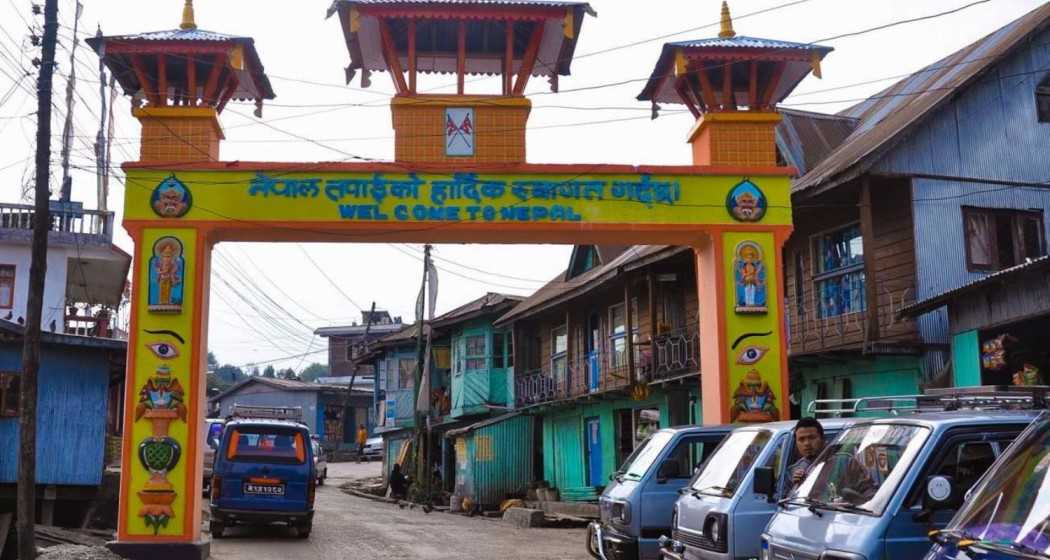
541,388,701,489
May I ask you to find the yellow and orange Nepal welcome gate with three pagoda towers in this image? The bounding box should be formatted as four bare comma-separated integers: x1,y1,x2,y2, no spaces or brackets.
90,0,828,558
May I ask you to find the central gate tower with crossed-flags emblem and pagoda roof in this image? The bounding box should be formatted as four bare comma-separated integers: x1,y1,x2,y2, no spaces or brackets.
329,0,594,165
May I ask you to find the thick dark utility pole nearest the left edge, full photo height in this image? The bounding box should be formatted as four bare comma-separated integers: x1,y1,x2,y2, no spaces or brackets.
17,0,59,560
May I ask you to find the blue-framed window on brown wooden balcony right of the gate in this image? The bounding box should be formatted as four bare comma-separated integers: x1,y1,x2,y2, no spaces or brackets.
813,224,866,318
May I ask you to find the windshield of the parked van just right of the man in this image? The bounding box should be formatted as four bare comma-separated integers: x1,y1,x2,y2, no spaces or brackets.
795,423,929,515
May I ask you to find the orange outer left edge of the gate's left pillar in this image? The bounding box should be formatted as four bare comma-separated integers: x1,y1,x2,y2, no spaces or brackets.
117,229,148,541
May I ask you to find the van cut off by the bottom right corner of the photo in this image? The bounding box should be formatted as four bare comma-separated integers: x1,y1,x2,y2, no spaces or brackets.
926,413,1050,560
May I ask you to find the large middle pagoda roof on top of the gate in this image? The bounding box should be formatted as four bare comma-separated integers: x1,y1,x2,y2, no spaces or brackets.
328,0,596,85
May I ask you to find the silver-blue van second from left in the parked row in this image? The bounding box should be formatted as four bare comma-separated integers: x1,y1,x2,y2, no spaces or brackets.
662,418,856,560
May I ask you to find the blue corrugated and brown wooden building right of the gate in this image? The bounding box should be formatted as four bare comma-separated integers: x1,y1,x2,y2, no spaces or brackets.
777,5,1050,412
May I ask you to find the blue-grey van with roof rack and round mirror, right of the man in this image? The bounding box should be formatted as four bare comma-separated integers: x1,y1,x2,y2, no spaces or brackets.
761,388,1037,560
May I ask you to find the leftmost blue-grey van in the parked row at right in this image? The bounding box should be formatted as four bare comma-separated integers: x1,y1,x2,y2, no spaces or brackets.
587,426,732,560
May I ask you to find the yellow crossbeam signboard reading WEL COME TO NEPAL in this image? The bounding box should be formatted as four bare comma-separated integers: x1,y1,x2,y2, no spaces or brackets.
125,168,791,226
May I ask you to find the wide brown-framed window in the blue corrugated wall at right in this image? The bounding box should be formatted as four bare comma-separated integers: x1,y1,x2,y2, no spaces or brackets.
963,207,1044,272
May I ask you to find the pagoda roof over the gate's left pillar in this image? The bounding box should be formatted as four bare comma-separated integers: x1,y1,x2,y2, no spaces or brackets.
87,27,275,106
